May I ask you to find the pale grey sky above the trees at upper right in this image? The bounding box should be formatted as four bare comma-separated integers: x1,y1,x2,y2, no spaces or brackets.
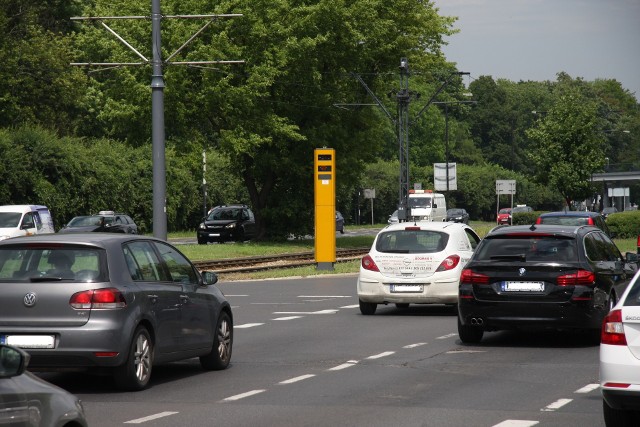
433,0,640,101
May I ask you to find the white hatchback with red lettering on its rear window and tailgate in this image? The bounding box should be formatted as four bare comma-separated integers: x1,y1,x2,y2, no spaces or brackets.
358,222,480,315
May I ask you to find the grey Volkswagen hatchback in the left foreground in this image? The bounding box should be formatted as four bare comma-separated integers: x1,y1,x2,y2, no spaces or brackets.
0,233,233,390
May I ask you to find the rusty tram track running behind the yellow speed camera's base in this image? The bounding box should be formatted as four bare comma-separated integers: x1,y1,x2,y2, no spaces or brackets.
194,248,369,273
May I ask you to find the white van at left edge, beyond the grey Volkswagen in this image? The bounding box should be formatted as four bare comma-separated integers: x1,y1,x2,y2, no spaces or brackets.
0,205,55,240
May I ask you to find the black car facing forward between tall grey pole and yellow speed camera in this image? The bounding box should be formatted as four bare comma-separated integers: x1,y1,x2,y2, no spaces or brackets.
196,205,257,245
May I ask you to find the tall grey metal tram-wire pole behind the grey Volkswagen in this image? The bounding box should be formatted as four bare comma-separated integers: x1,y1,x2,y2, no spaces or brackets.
151,0,167,240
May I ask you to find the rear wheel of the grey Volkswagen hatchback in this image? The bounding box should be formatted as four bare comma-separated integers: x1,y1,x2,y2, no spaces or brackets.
115,326,153,391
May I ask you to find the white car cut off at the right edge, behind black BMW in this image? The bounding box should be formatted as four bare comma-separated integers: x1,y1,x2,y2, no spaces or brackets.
600,271,640,427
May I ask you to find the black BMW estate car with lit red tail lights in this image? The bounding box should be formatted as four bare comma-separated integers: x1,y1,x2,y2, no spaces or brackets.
458,225,637,343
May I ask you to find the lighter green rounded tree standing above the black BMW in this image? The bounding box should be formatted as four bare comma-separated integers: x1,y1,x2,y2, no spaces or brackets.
527,88,604,207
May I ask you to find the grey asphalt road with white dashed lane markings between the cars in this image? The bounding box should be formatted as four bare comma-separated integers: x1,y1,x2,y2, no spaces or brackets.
37,275,603,427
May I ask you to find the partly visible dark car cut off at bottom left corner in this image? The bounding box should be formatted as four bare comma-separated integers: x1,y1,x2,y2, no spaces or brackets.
0,344,87,427
